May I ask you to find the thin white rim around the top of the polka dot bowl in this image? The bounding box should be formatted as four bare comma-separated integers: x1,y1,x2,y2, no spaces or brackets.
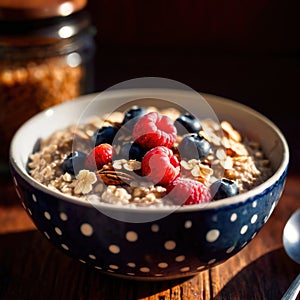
9,88,289,214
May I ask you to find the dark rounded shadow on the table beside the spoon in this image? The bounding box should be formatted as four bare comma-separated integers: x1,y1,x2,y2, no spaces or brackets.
214,248,300,300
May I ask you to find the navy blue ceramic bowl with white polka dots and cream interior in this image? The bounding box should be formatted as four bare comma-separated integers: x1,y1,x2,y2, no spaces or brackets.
10,89,289,280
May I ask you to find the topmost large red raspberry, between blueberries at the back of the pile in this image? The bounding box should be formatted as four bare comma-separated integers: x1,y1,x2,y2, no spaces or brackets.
132,112,177,149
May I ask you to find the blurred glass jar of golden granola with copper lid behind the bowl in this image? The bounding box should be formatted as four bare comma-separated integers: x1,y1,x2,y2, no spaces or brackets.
0,0,95,173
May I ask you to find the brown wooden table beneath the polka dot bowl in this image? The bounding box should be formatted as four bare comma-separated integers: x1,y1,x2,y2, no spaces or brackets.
0,175,300,300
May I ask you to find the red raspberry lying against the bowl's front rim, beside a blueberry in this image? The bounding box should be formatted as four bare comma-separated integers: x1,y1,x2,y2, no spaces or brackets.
166,177,211,205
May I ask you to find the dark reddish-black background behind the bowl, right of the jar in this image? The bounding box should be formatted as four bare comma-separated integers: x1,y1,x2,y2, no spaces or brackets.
86,0,300,173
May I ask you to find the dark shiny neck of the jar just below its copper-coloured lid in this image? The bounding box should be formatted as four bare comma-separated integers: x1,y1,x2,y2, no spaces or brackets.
0,9,96,60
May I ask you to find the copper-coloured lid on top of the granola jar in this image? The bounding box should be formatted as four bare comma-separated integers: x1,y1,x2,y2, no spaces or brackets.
0,0,87,20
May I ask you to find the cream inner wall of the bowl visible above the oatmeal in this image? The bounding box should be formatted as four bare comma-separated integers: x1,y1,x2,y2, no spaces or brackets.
10,89,289,209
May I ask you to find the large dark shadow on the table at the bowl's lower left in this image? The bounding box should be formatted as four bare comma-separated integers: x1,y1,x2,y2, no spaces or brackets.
0,231,191,300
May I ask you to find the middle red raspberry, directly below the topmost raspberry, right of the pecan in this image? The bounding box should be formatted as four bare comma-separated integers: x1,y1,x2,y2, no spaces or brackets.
142,146,180,185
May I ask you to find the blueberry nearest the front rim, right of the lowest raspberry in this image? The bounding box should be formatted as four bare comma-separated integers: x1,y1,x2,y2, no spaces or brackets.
210,178,239,200
